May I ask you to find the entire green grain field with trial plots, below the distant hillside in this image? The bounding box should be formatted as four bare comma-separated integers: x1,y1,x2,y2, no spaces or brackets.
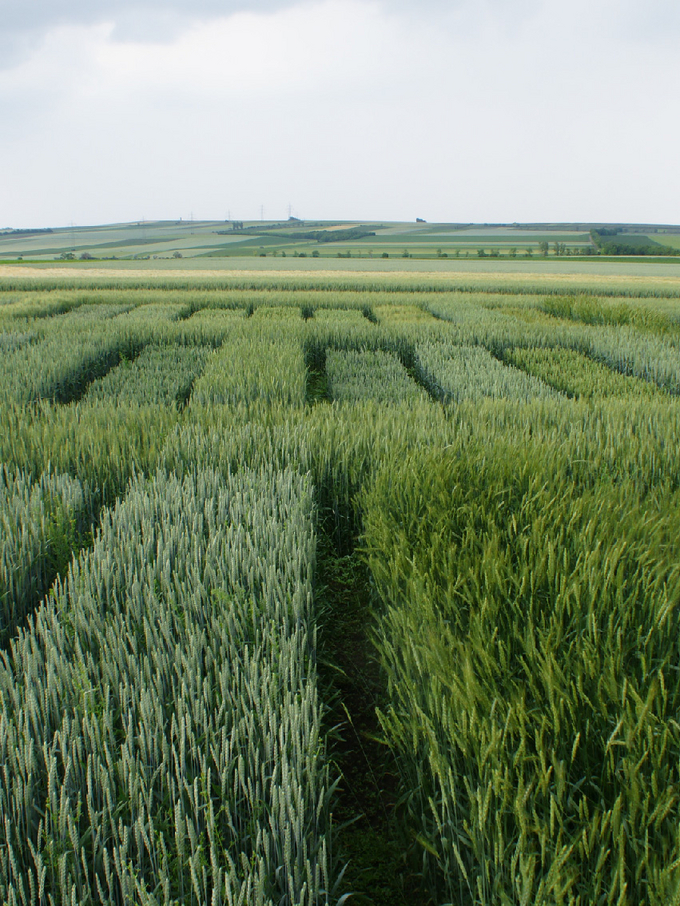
0,260,680,906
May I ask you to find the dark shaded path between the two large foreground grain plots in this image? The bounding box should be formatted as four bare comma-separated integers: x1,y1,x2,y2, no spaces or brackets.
318,544,431,906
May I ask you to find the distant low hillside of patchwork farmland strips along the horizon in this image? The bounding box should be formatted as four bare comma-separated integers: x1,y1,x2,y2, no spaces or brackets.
0,221,680,262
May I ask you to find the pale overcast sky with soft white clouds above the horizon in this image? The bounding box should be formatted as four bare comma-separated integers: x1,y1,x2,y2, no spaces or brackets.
0,0,680,227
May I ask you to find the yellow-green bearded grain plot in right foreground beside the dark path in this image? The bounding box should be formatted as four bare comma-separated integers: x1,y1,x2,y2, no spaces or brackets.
364,439,680,906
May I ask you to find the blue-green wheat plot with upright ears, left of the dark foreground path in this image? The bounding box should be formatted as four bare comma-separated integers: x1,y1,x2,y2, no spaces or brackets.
0,470,331,906
